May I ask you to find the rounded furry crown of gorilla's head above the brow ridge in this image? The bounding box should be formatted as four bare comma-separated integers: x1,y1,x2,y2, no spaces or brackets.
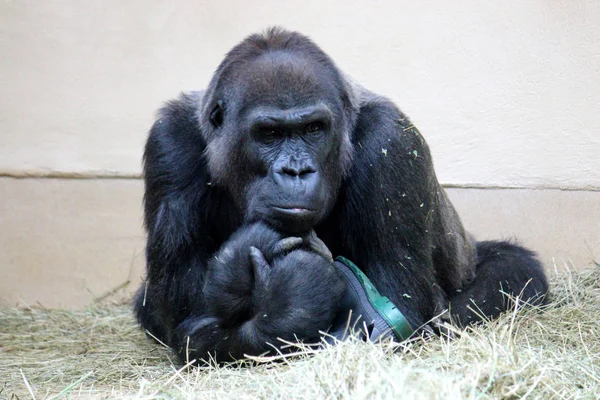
202,27,358,127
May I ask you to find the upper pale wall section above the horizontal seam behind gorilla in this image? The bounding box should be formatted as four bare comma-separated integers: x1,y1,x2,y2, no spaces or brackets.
0,0,600,188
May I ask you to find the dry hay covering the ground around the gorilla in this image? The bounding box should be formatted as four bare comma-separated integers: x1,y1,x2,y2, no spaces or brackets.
0,265,600,399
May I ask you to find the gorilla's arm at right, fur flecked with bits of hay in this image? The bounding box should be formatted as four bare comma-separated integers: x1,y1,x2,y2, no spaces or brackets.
319,96,475,328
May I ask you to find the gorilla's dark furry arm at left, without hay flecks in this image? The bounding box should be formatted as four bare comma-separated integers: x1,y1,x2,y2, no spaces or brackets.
135,94,220,345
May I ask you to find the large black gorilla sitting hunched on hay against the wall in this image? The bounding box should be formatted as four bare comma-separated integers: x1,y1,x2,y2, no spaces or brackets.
135,29,547,361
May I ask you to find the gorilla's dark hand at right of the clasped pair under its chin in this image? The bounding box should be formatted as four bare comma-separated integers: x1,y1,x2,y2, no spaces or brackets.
250,233,346,341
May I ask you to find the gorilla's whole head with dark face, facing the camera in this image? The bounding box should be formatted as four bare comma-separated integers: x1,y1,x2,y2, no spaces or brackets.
198,29,357,233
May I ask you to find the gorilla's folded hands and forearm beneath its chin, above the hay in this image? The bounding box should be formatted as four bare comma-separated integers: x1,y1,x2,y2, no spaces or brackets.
175,222,345,362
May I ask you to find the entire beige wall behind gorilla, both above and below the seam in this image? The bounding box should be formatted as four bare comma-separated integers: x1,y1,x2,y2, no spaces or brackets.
0,0,600,306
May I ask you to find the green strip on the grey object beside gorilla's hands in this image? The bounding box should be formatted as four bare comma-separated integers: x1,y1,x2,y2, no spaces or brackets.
336,256,414,340
